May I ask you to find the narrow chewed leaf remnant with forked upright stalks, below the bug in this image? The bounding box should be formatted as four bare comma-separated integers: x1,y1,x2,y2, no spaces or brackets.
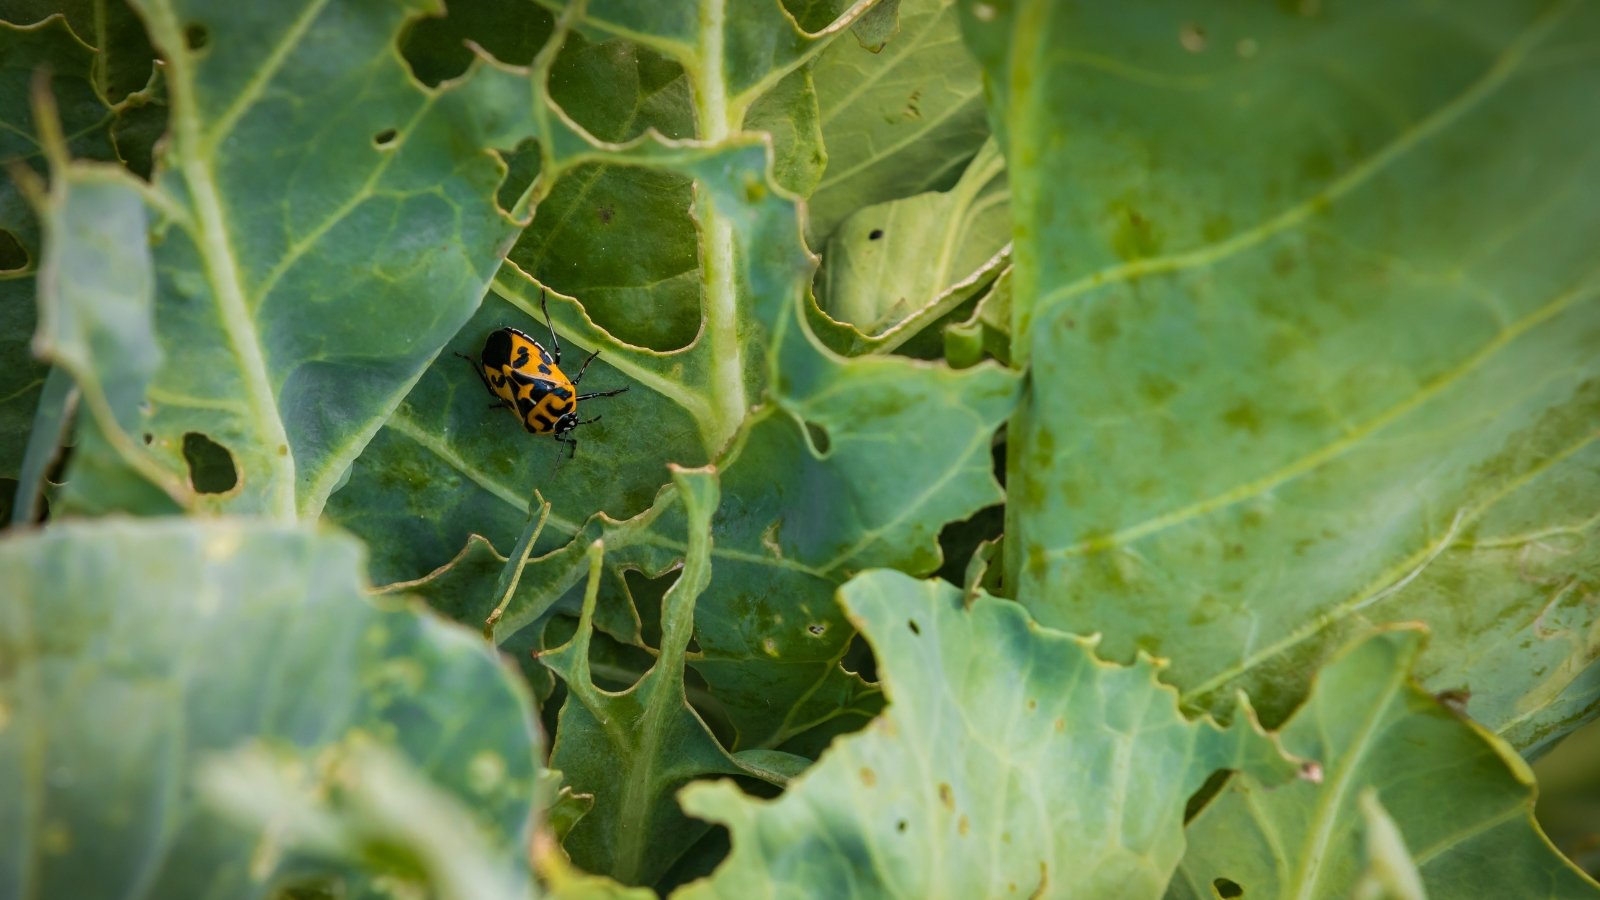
541,469,741,884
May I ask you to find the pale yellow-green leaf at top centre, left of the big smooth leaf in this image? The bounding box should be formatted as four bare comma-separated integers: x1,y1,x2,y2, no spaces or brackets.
806,0,989,247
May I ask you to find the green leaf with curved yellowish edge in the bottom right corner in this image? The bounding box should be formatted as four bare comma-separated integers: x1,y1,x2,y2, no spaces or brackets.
1173,626,1600,900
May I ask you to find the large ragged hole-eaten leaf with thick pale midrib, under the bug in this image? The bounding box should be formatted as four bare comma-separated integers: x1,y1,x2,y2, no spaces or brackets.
331,10,1016,751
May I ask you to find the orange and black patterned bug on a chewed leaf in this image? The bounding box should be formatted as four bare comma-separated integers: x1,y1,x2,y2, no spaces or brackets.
456,290,627,460
